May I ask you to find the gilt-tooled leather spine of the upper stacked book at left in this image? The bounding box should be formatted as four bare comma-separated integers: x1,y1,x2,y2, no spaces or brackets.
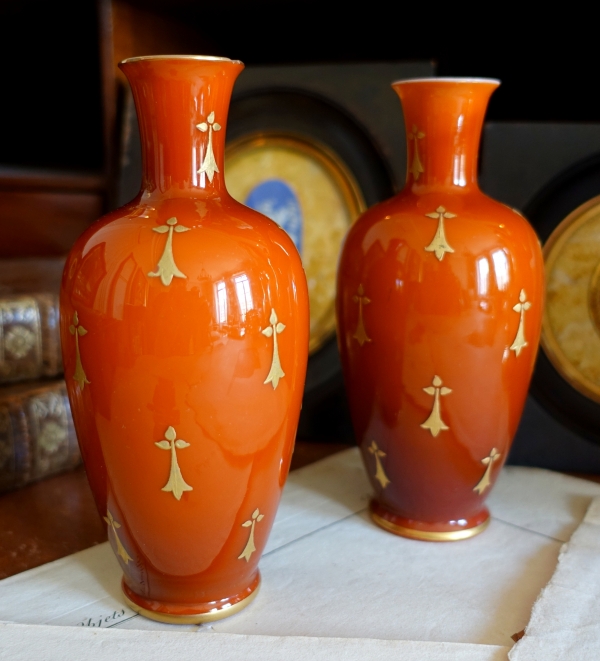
0,293,62,383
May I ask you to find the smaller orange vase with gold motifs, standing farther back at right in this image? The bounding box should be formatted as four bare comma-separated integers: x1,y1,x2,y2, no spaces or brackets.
337,78,543,541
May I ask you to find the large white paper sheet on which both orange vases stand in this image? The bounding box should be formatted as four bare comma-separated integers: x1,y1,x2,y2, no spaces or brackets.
0,449,600,659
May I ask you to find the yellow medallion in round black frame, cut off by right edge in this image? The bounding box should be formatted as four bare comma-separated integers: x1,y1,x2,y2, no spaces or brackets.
525,155,600,444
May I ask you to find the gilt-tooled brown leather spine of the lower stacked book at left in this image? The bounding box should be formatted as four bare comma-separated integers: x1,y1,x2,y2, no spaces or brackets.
0,379,81,492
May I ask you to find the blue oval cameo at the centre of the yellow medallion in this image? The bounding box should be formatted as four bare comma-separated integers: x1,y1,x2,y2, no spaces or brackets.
245,179,302,254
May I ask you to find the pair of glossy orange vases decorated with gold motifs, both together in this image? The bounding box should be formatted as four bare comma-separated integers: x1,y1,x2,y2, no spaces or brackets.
61,56,543,623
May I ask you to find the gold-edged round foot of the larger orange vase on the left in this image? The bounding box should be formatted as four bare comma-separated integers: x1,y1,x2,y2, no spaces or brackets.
121,573,260,624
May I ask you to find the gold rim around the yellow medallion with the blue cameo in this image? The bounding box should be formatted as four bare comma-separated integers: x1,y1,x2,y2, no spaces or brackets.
225,131,367,355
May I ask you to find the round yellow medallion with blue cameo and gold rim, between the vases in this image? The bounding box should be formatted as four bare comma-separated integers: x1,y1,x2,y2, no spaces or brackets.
225,131,366,354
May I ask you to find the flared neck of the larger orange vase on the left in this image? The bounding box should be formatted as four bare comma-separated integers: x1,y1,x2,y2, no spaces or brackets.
119,56,243,197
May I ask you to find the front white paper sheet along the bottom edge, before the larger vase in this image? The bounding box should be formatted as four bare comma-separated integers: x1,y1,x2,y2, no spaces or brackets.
0,623,508,661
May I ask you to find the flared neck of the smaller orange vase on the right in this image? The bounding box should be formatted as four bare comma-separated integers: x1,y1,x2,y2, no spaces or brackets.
393,78,499,194
